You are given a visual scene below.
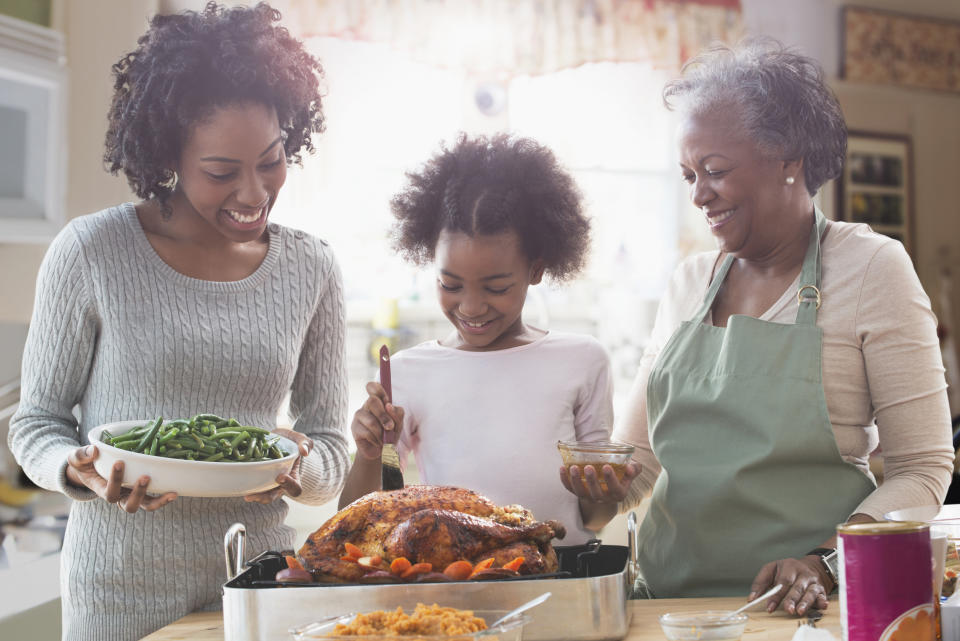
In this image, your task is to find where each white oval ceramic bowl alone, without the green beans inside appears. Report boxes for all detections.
[88,420,297,497]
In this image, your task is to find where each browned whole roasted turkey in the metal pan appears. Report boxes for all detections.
[298,485,566,583]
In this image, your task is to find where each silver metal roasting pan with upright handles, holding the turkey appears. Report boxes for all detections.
[223,513,637,641]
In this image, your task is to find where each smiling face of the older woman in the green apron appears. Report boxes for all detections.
[678,111,787,258]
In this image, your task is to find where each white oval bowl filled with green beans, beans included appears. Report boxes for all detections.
[87,414,297,497]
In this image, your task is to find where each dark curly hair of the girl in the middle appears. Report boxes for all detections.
[390,134,590,282]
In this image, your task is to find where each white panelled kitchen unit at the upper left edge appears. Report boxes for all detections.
[0,16,66,242]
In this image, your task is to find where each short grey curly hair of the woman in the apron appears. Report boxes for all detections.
[663,38,847,196]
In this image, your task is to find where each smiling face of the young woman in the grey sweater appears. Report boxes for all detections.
[175,102,287,243]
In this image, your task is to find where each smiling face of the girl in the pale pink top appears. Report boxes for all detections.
[434,230,543,351]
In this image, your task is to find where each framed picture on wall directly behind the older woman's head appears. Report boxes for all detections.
[837,131,916,262]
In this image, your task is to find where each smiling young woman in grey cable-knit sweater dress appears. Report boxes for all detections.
[10,4,347,641]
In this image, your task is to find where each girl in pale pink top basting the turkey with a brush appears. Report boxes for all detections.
[340,135,636,543]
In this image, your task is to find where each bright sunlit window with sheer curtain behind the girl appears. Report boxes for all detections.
[273,0,739,399]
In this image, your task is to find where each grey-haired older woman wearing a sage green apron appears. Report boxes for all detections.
[564,41,953,614]
